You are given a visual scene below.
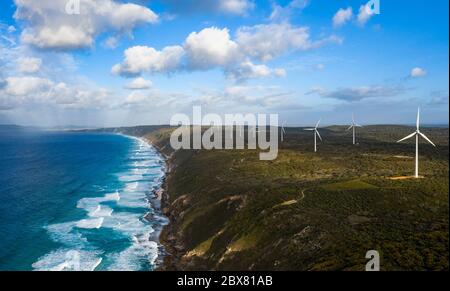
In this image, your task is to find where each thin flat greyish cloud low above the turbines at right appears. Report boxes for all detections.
[306,86,405,102]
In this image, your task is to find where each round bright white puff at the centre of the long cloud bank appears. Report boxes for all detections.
[184,27,239,69]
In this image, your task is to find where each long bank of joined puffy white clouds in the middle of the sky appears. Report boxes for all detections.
[112,23,342,80]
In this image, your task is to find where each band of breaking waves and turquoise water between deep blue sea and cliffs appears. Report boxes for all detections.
[33,137,167,271]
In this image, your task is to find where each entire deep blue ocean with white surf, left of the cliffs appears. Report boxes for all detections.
[0,131,167,271]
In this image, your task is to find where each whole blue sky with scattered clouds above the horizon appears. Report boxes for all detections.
[0,0,449,127]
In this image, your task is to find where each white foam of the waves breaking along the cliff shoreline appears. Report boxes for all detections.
[33,139,164,271]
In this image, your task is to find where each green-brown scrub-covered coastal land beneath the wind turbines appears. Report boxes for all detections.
[110,126,449,271]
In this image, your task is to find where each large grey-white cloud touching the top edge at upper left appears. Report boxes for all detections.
[14,0,158,50]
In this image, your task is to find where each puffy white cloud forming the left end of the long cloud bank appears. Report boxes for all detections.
[112,46,184,75]
